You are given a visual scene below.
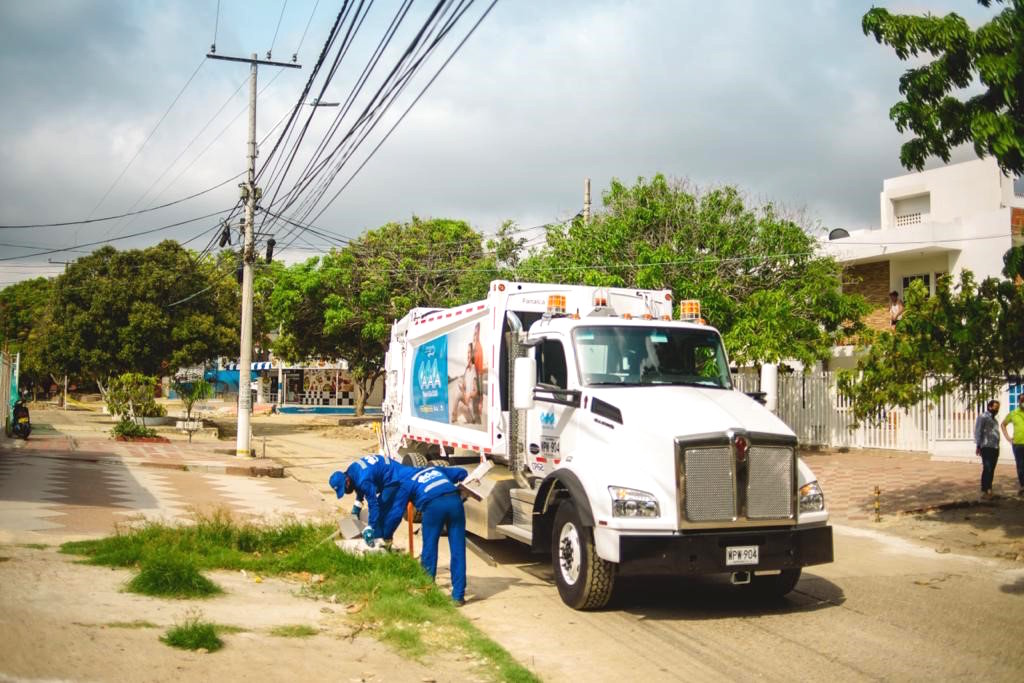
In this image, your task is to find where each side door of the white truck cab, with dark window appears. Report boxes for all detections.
[526,336,580,477]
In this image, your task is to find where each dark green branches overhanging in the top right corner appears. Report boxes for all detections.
[861,0,1024,175]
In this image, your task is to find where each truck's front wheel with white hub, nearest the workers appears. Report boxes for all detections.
[551,501,615,609]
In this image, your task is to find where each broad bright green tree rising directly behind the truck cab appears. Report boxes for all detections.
[516,175,867,364]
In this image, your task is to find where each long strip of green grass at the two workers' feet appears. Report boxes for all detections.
[60,512,538,682]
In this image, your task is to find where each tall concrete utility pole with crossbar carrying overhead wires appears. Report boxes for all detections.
[206,52,302,458]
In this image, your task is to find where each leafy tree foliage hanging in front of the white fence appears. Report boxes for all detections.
[840,247,1024,421]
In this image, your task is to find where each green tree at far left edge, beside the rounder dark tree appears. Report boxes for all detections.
[0,278,53,392]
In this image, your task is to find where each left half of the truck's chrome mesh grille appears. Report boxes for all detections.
[683,445,736,522]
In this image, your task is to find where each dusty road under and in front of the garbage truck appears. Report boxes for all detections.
[464,527,1024,683]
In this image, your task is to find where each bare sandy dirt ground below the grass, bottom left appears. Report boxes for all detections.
[0,546,482,683]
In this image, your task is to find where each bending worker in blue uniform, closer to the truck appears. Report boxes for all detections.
[381,467,468,605]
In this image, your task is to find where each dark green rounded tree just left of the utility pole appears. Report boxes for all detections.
[44,241,239,390]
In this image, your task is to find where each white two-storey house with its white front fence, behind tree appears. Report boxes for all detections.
[777,158,1024,461]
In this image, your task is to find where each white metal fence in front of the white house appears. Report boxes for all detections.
[733,373,1007,451]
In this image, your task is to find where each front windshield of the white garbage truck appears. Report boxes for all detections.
[572,326,732,389]
